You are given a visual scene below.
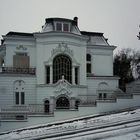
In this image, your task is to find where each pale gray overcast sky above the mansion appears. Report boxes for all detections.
[0,0,140,50]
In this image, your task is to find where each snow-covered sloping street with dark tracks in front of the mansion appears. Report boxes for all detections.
[0,109,140,140]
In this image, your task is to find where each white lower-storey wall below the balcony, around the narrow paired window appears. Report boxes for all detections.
[0,75,36,107]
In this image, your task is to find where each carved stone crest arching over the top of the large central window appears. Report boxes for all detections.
[51,42,73,57]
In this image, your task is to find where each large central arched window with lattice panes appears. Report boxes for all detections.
[53,55,72,83]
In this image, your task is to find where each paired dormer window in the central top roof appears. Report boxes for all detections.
[55,22,70,32]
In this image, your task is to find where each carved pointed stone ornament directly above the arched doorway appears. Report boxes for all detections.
[54,76,72,95]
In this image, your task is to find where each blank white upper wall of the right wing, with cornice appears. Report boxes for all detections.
[87,46,113,76]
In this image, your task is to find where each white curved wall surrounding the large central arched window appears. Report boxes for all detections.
[36,33,86,85]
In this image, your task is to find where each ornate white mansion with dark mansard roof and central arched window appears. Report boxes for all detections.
[0,17,138,125]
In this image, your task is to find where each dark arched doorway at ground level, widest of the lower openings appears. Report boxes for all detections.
[56,97,70,109]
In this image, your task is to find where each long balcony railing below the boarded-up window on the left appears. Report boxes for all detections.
[0,67,36,75]
